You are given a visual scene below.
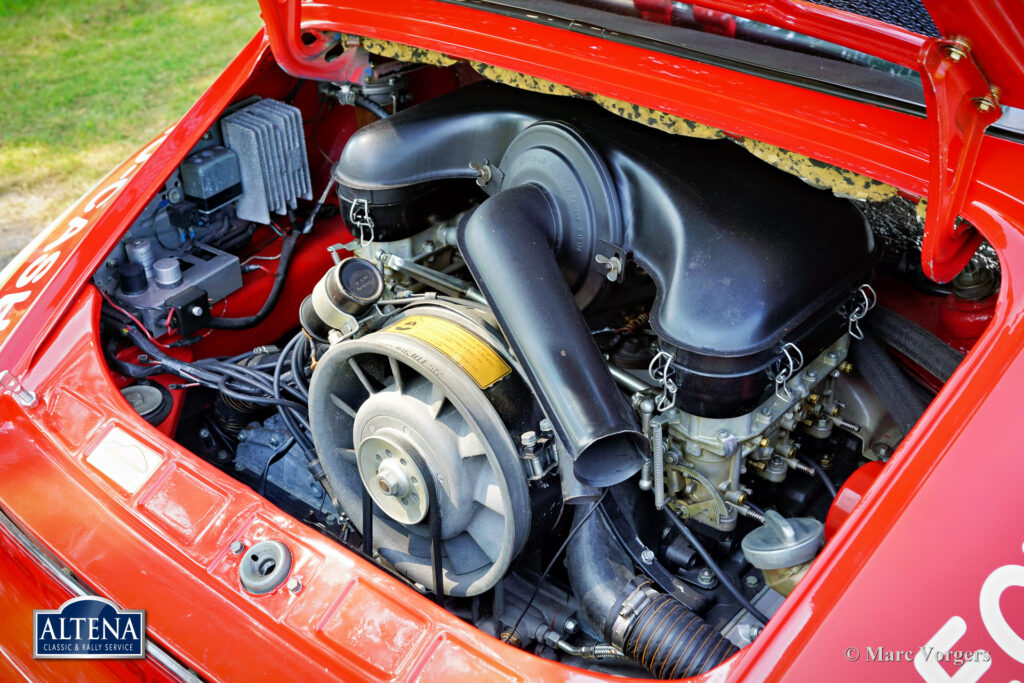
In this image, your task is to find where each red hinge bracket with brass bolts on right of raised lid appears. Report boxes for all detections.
[921,37,1001,283]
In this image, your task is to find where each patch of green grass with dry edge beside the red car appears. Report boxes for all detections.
[0,0,260,240]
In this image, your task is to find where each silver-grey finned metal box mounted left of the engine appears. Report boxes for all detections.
[221,99,312,224]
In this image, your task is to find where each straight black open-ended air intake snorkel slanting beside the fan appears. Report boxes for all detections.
[459,183,642,486]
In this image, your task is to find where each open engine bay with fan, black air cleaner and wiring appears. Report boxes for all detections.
[93,47,999,678]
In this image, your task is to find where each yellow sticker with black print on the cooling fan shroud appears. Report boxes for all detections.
[381,315,512,389]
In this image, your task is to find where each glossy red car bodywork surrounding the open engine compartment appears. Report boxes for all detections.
[0,0,1024,681]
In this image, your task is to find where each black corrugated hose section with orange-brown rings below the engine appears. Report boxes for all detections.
[623,593,737,679]
